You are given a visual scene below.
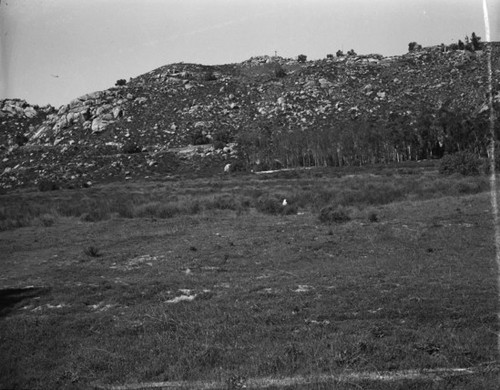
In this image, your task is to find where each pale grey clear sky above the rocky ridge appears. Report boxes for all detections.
[0,0,500,107]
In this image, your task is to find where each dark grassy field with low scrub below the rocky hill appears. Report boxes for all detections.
[0,168,499,389]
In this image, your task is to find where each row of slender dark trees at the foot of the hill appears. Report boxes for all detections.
[236,107,499,170]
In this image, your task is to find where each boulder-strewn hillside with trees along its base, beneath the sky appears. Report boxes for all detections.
[0,43,500,189]
